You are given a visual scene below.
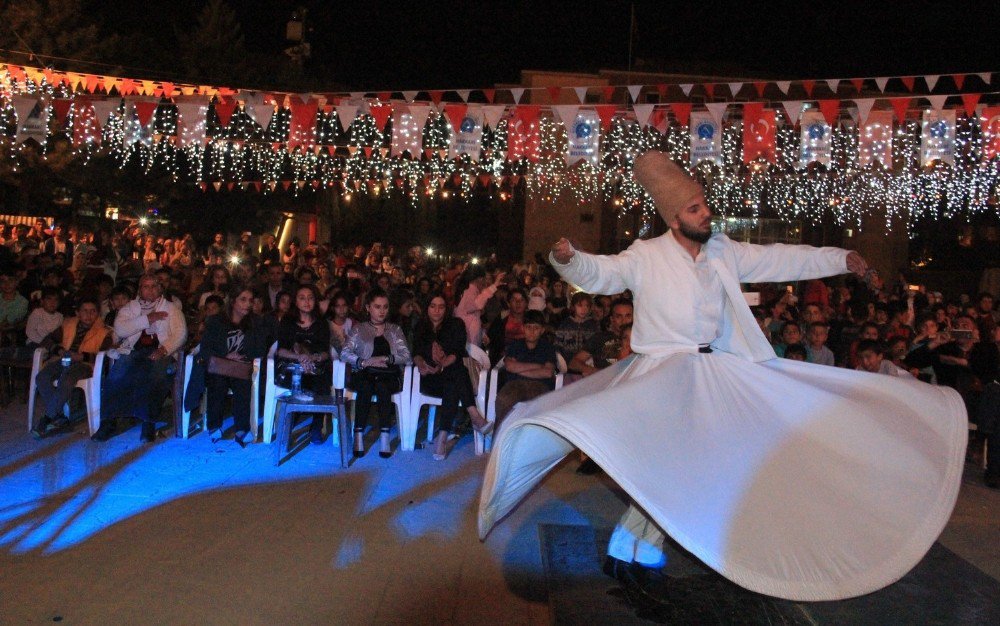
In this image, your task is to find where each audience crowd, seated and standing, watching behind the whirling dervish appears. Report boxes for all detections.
[0,220,1000,480]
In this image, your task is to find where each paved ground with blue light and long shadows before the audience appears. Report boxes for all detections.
[0,402,1000,624]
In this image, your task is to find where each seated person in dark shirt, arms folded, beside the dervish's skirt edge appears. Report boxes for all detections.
[496,311,556,424]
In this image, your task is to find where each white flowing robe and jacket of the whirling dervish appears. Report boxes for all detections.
[479,233,967,600]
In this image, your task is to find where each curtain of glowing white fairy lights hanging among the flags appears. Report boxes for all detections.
[0,64,1000,229]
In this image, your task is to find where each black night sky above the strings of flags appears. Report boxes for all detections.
[100,0,1000,90]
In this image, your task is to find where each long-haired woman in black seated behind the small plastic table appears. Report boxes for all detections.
[277,285,333,444]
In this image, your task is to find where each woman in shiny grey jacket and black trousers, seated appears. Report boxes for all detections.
[340,287,410,459]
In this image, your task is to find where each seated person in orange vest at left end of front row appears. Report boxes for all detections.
[31,296,111,439]
